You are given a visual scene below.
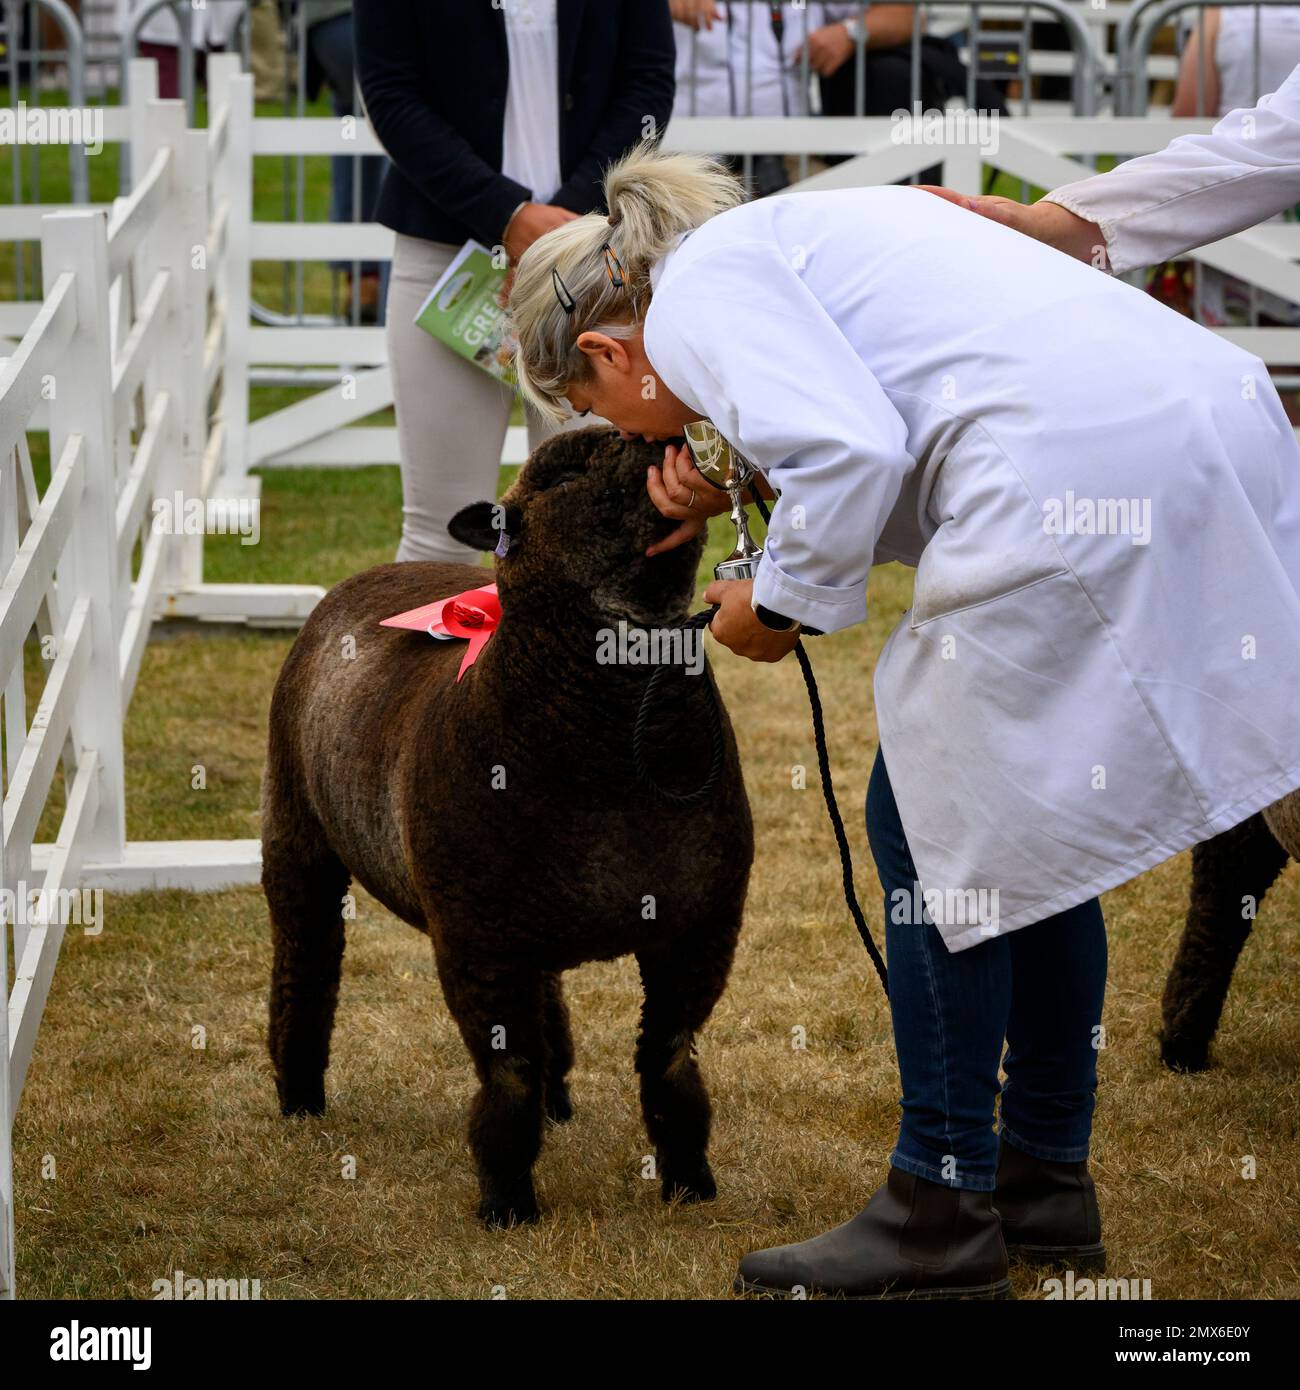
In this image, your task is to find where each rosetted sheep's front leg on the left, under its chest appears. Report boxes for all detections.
[438,956,546,1227]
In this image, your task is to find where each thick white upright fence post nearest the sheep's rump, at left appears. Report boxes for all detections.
[40,210,127,863]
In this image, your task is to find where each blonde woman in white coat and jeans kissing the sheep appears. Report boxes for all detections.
[512,141,1300,1295]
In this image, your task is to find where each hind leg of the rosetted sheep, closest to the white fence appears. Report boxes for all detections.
[261,838,349,1115]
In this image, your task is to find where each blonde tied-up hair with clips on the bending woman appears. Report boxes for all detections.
[509,142,745,420]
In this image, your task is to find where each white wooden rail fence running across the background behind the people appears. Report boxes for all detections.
[224,96,1300,491]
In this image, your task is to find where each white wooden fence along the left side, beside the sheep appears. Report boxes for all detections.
[0,60,321,1297]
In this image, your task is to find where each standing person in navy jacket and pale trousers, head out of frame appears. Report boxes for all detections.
[353,0,674,562]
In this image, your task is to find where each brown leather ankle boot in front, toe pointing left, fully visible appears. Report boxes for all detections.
[733,1168,1011,1298]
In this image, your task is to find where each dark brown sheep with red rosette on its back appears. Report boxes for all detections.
[263,430,754,1225]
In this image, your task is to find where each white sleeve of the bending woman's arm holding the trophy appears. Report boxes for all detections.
[645,242,913,632]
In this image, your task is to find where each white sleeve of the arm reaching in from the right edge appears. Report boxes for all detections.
[1043,67,1300,275]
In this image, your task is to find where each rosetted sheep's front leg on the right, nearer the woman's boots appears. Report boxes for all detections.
[637,924,738,1202]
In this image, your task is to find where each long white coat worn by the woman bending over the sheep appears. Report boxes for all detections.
[645,188,1300,951]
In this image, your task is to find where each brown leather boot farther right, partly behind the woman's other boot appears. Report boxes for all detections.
[993,1140,1105,1272]
